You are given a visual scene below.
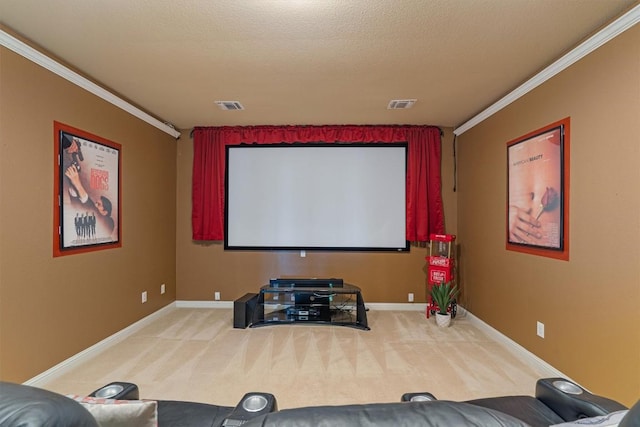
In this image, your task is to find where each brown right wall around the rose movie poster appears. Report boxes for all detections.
[458,26,640,405]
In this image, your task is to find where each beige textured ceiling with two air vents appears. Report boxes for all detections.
[0,0,638,129]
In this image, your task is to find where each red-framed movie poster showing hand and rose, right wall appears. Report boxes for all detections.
[507,118,570,260]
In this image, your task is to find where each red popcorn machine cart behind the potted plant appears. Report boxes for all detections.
[426,234,456,319]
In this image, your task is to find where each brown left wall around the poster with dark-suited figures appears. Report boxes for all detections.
[0,48,176,381]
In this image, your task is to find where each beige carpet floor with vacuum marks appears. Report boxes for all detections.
[43,308,554,409]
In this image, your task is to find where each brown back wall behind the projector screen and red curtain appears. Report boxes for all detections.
[177,129,457,303]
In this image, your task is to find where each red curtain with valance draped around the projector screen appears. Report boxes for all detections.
[191,126,445,242]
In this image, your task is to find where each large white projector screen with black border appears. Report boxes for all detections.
[224,143,409,251]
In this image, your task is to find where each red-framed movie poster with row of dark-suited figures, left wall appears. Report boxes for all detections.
[53,122,122,256]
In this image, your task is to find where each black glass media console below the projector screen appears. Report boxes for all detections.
[250,279,369,330]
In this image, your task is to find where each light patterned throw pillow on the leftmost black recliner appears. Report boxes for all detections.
[67,395,158,427]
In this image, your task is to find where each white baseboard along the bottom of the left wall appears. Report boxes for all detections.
[24,303,176,387]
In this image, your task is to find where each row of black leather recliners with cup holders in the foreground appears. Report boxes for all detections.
[0,378,640,427]
